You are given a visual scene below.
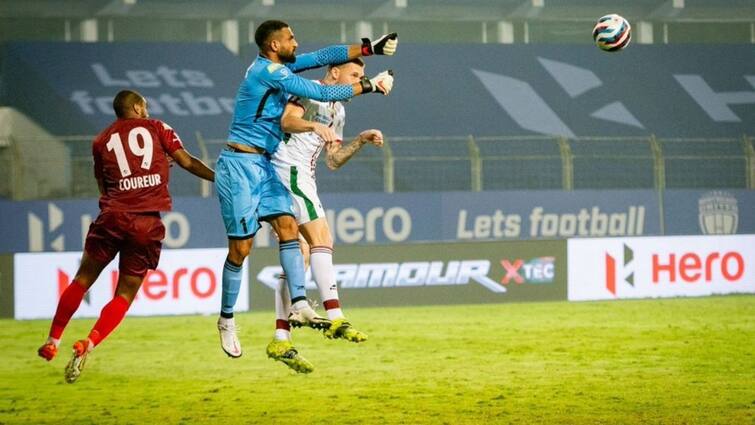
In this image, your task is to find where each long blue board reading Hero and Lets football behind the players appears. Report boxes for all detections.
[0,190,661,252]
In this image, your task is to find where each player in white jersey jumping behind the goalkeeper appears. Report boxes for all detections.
[272,58,383,342]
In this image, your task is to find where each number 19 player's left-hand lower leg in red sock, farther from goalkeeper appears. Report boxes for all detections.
[37,252,107,361]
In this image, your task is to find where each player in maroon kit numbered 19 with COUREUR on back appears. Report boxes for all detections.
[37,90,215,383]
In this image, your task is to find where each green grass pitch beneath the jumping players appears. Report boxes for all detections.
[0,296,755,425]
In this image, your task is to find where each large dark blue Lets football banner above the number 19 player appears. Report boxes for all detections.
[0,42,245,139]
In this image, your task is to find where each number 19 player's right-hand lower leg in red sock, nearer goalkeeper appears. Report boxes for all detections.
[65,273,144,384]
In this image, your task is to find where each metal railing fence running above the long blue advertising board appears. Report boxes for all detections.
[0,133,755,199]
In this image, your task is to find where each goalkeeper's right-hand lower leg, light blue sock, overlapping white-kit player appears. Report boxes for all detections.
[270,215,330,329]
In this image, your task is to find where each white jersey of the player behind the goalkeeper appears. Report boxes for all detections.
[272,81,346,179]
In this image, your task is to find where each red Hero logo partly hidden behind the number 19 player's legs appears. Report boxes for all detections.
[58,267,218,298]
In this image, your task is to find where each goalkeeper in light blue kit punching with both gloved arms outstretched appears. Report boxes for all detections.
[215,20,397,372]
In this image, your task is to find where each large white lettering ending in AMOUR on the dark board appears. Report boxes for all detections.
[257,260,506,294]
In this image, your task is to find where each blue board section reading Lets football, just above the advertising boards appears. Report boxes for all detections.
[442,190,660,240]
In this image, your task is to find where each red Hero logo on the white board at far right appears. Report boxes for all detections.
[605,244,745,296]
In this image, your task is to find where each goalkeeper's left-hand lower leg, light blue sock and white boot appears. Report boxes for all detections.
[217,238,254,358]
